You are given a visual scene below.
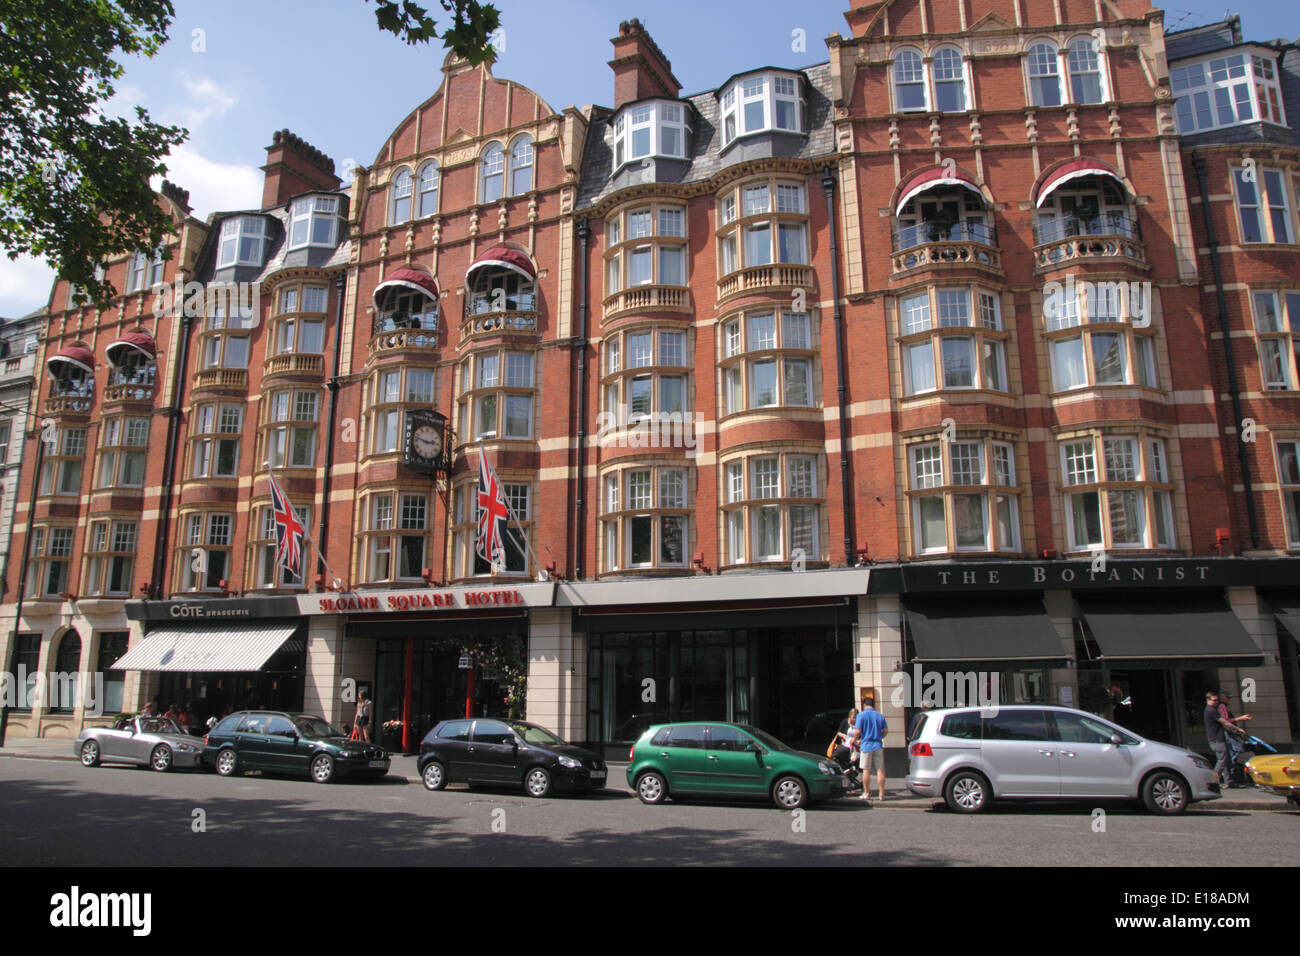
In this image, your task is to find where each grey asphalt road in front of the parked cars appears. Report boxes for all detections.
[0,757,1300,868]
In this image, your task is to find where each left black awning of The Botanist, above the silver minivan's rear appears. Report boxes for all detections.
[905,597,1069,665]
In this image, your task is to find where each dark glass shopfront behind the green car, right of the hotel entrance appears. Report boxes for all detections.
[586,611,853,749]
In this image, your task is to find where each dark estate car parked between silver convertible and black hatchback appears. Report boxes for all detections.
[203,710,390,783]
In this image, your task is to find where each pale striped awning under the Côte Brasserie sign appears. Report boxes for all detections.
[112,624,296,671]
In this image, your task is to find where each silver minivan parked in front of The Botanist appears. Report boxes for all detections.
[907,705,1221,813]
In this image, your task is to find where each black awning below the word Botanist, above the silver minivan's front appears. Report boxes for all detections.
[1078,594,1264,667]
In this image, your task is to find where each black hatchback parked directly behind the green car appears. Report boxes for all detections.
[419,718,607,797]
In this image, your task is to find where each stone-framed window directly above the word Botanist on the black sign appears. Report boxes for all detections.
[1061,434,1175,551]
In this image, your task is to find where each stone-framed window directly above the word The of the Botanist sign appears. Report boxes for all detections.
[907,438,1021,555]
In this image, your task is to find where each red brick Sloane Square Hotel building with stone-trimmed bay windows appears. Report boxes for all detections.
[5,0,1300,752]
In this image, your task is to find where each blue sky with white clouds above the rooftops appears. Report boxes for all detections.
[0,0,1300,316]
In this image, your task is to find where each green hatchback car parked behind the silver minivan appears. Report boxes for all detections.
[628,723,849,810]
